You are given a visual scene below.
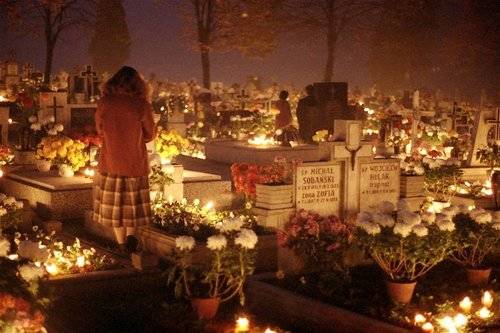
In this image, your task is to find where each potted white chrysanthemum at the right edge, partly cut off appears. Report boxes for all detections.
[451,206,500,285]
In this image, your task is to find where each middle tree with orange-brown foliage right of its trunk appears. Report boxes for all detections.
[182,0,282,88]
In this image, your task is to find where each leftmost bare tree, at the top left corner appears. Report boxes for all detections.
[0,0,94,85]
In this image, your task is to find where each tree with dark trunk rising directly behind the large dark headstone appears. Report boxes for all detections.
[286,0,379,82]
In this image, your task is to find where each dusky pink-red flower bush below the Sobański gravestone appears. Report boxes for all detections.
[278,209,353,273]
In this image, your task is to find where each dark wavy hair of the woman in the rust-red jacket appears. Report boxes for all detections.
[103,66,149,100]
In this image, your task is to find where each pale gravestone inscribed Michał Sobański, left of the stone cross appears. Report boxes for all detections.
[295,162,344,216]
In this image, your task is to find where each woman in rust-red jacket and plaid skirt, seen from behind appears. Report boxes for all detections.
[93,66,155,249]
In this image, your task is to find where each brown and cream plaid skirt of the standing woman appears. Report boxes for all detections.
[93,172,151,227]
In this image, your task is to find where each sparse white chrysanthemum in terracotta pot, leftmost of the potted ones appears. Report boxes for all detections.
[168,228,257,319]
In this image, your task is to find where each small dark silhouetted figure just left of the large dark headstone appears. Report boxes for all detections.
[297,85,318,143]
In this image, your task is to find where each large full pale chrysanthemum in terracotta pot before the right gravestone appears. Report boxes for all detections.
[356,202,455,303]
